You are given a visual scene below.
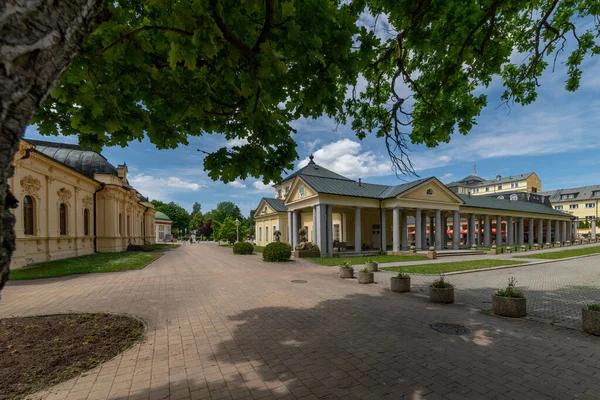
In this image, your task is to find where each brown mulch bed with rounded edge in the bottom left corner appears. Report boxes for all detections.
[0,314,145,400]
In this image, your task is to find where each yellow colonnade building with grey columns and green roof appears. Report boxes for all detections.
[254,156,573,256]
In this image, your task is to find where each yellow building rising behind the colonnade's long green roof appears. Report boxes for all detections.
[446,172,542,196]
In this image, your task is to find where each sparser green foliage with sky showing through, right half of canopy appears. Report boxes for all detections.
[338,0,600,173]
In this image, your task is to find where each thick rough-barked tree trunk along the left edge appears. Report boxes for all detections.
[0,0,105,296]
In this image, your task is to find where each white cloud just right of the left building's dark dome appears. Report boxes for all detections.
[129,173,206,201]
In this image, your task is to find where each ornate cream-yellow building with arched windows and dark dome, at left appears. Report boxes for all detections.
[9,140,155,268]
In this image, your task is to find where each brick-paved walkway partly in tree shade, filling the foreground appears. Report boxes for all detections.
[0,244,600,400]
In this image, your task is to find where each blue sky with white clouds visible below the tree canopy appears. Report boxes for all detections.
[25,42,600,215]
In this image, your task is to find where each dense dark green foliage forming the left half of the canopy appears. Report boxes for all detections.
[35,0,364,184]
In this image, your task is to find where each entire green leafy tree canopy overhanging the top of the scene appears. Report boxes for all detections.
[30,0,600,182]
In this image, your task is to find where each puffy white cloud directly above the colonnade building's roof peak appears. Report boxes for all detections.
[298,138,393,178]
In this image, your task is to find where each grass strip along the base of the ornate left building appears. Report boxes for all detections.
[10,251,164,280]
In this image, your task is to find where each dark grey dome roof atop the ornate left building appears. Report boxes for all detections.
[25,139,117,178]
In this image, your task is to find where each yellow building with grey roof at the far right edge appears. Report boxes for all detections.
[540,185,600,238]
